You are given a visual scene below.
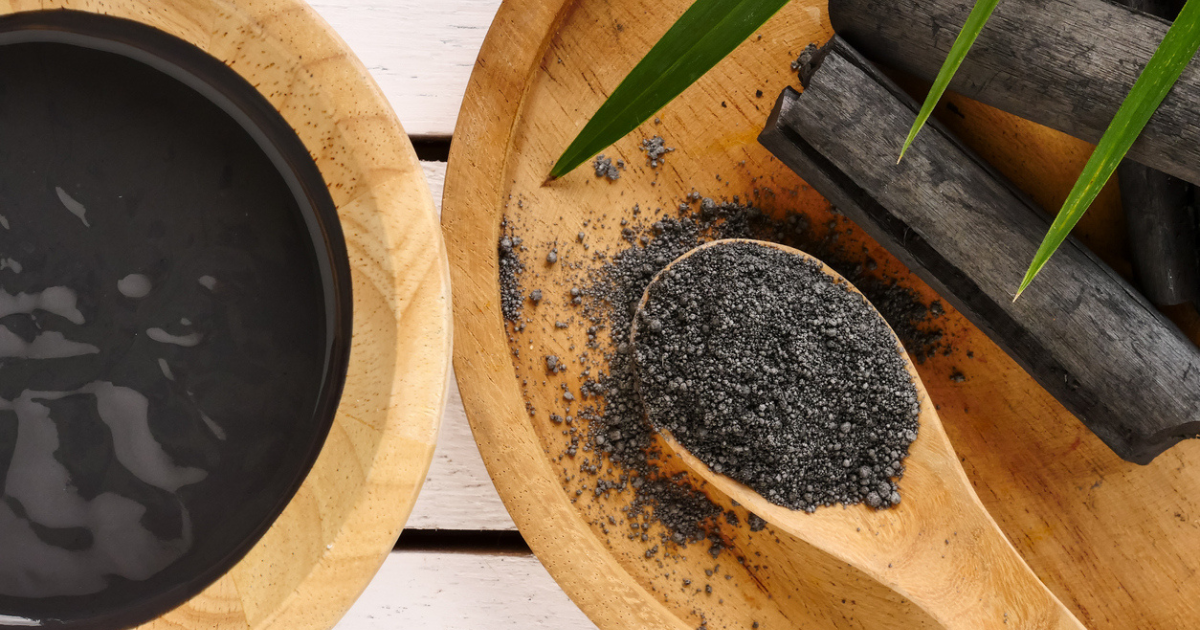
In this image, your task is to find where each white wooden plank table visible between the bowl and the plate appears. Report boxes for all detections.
[302,0,595,630]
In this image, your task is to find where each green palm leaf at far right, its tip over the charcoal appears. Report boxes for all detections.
[1013,0,1200,300]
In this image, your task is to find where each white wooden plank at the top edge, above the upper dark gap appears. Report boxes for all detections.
[310,0,500,137]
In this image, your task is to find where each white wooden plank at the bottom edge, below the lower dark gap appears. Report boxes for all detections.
[337,552,596,630]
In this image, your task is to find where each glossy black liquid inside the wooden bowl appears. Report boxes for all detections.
[0,43,328,604]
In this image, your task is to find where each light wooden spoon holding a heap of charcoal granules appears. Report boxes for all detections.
[631,239,1084,630]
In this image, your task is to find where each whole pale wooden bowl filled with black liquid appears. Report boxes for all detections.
[0,0,450,629]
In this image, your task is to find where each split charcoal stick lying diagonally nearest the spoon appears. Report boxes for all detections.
[760,37,1200,464]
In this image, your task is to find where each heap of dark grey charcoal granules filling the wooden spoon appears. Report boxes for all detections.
[634,241,920,512]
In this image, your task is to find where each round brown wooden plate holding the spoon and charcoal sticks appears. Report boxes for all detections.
[443,0,1200,629]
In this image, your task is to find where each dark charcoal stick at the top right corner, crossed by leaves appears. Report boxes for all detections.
[829,0,1200,184]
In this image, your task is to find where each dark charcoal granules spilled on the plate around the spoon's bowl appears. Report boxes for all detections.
[500,191,944,553]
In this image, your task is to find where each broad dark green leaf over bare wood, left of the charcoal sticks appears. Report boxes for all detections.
[550,0,787,179]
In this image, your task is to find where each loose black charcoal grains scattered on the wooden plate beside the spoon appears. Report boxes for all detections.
[498,198,949,559]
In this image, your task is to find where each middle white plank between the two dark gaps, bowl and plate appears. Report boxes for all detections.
[404,162,517,530]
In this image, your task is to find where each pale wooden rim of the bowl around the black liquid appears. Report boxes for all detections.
[0,0,450,630]
